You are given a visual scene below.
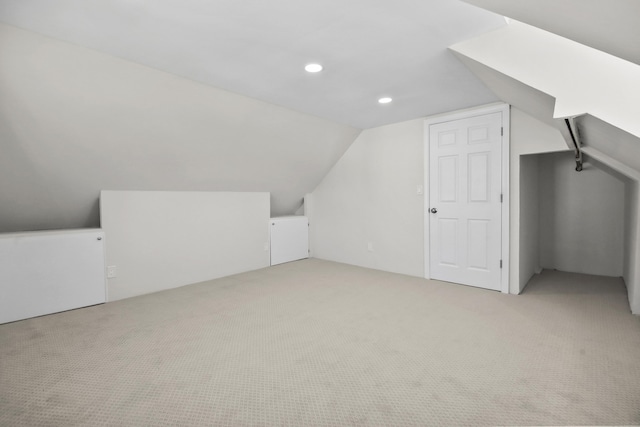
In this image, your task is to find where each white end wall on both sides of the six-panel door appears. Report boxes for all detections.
[305,108,567,293]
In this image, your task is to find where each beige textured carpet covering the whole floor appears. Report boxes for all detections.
[0,259,640,426]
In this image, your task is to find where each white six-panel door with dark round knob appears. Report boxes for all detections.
[426,112,502,290]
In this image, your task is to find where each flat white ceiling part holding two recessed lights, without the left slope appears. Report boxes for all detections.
[0,0,505,128]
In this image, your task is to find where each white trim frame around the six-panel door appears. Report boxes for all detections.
[423,102,510,294]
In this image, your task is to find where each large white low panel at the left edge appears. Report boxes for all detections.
[0,229,106,323]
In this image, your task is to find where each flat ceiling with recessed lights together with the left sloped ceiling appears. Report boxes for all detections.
[0,0,505,232]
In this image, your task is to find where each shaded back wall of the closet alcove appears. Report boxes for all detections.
[539,153,625,276]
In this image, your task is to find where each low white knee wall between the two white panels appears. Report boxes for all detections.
[100,191,269,301]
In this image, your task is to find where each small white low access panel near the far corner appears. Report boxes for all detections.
[269,216,309,265]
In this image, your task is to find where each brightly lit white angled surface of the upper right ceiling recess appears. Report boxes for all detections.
[451,21,640,136]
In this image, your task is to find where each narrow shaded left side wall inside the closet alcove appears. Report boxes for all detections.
[518,155,540,287]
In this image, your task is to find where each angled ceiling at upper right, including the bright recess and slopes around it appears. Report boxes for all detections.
[451,0,640,170]
